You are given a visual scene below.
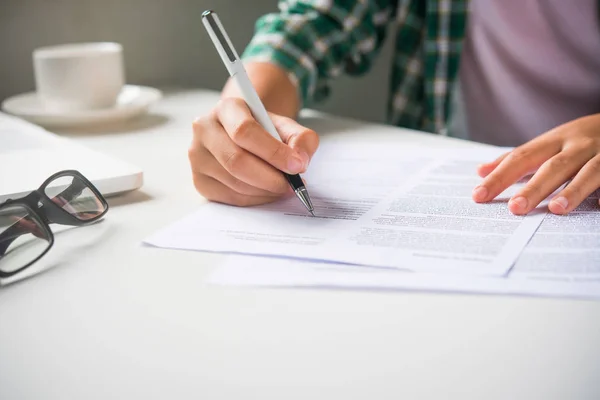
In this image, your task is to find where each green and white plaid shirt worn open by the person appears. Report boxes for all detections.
[243,0,468,133]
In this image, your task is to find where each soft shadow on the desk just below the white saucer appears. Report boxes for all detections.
[53,113,170,137]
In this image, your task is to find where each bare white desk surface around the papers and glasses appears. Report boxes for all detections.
[0,90,600,400]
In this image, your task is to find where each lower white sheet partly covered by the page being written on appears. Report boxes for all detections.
[210,191,600,299]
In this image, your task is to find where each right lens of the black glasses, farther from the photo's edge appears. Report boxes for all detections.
[44,175,106,221]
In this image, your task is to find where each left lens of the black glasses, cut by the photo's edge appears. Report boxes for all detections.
[0,206,50,274]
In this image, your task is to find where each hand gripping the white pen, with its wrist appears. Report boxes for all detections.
[189,10,319,212]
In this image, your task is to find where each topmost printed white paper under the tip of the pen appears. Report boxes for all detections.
[146,144,545,275]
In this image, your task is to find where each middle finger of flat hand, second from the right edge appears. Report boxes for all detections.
[508,149,592,215]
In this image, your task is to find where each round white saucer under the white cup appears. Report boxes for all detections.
[2,85,162,128]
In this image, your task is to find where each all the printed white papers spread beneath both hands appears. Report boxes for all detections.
[146,144,600,297]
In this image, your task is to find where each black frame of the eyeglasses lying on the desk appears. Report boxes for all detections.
[0,170,108,278]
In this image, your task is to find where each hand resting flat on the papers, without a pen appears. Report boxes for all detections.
[473,114,600,215]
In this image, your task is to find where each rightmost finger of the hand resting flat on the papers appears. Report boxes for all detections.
[548,155,600,215]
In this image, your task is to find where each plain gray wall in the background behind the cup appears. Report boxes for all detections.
[0,0,392,121]
